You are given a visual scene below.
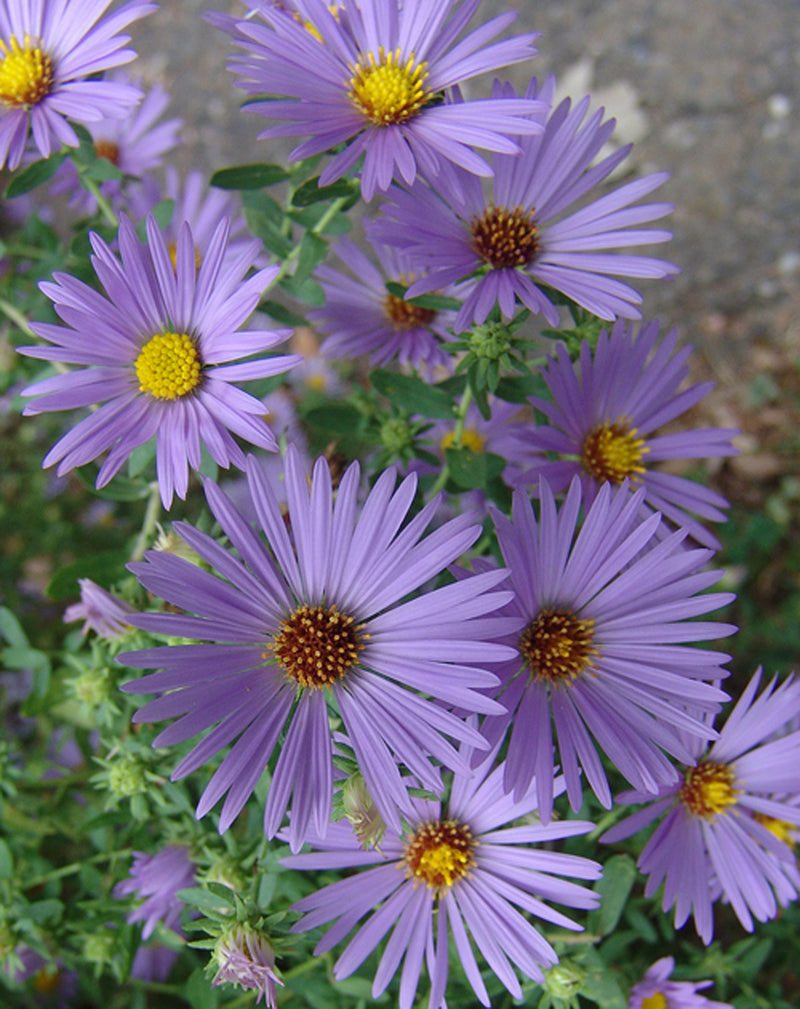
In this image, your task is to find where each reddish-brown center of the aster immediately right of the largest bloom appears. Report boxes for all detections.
[520,609,597,685]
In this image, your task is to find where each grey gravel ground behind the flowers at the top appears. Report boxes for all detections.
[129,0,800,382]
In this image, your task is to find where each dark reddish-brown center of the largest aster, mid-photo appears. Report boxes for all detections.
[263,605,369,688]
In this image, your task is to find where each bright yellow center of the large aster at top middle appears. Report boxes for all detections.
[348,45,432,126]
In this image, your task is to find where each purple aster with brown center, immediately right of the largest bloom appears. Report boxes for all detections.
[482,479,735,822]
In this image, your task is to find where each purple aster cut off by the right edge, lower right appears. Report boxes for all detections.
[601,669,800,944]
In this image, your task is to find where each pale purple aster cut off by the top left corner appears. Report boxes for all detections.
[0,0,155,171]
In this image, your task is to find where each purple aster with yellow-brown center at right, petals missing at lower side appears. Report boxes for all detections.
[508,322,738,548]
